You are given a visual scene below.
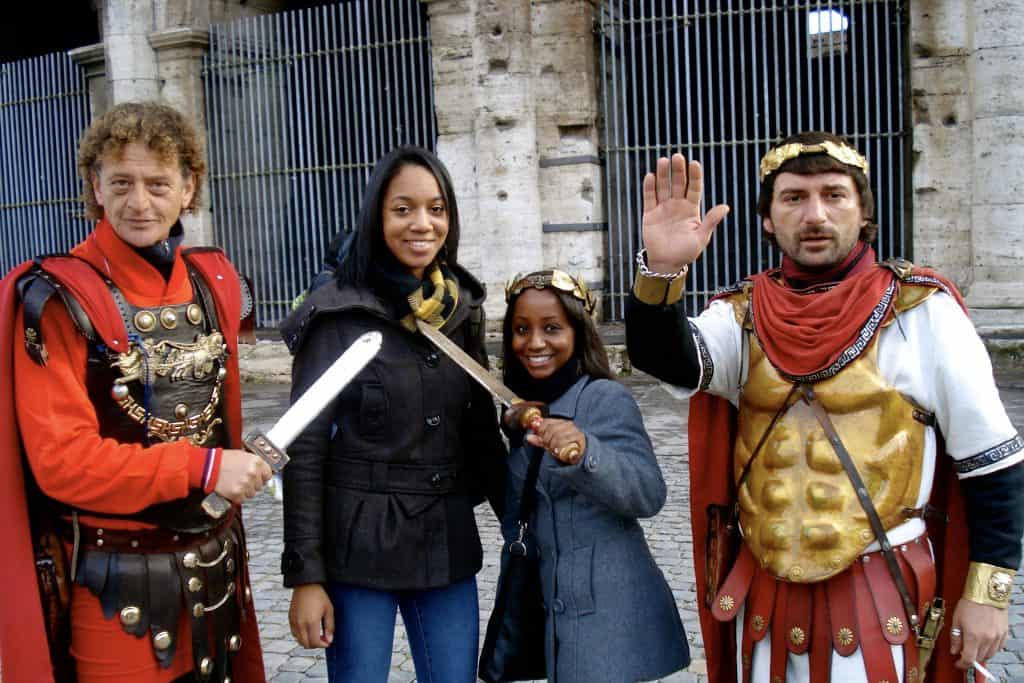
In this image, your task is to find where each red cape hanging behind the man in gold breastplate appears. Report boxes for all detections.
[688,268,969,683]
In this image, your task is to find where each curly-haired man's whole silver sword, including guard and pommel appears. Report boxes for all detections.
[203,332,382,519]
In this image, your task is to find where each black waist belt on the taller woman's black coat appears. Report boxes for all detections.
[328,458,461,495]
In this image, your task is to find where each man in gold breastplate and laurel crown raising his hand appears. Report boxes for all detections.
[627,132,1024,683]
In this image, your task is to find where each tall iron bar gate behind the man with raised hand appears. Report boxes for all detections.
[599,0,911,317]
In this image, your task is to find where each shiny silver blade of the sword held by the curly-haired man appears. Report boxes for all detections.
[266,332,383,451]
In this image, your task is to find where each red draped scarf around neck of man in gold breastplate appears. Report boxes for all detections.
[751,243,893,376]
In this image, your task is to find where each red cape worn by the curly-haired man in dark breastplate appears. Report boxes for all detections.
[0,240,266,683]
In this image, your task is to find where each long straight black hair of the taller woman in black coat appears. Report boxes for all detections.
[337,145,459,287]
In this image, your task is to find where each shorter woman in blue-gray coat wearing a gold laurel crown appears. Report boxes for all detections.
[502,270,690,683]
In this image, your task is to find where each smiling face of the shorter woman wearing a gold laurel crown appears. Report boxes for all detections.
[512,289,575,380]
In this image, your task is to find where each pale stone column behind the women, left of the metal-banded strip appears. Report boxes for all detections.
[425,0,542,318]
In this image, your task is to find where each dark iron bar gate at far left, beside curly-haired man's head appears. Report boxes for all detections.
[0,52,92,272]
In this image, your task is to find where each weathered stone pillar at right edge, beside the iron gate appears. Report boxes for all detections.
[910,0,1024,332]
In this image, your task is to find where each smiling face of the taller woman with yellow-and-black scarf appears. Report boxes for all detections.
[381,164,449,279]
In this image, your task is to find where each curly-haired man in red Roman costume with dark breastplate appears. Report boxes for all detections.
[0,103,270,683]
